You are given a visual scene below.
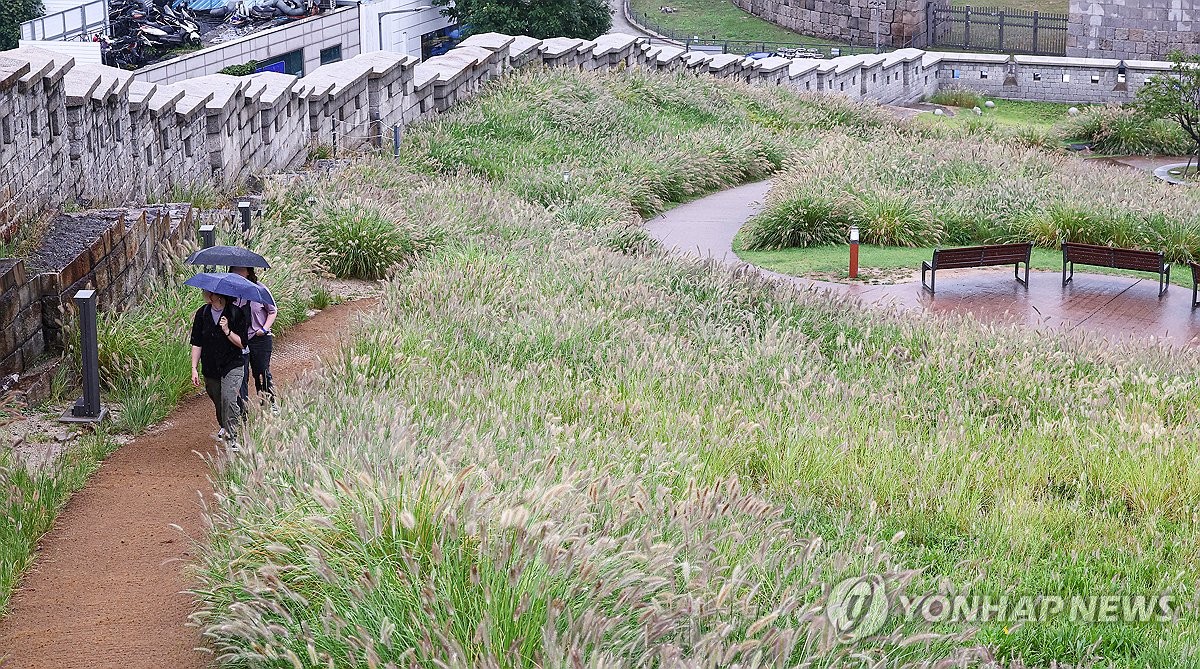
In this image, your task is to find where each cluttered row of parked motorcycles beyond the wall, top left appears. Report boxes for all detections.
[97,0,320,70]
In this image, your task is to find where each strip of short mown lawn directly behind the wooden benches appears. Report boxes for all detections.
[734,245,1192,288]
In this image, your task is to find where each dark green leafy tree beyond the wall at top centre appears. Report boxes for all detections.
[433,0,612,40]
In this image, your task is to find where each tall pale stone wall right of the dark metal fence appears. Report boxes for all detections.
[1067,0,1200,59]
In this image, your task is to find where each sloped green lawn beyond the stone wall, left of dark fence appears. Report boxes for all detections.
[629,0,830,47]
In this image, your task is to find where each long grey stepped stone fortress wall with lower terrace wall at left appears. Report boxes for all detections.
[0,34,1169,383]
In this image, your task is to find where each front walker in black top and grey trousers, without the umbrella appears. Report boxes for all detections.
[192,290,250,451]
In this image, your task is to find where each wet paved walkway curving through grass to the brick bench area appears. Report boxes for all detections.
[646,181,1200,345]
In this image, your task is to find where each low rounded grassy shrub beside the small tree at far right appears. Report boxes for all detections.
[1063,104,1192,156]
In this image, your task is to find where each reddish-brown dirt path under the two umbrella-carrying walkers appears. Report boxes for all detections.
[0,300,373,669]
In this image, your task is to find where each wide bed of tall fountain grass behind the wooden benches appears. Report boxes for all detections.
[740,131,1200,261]
